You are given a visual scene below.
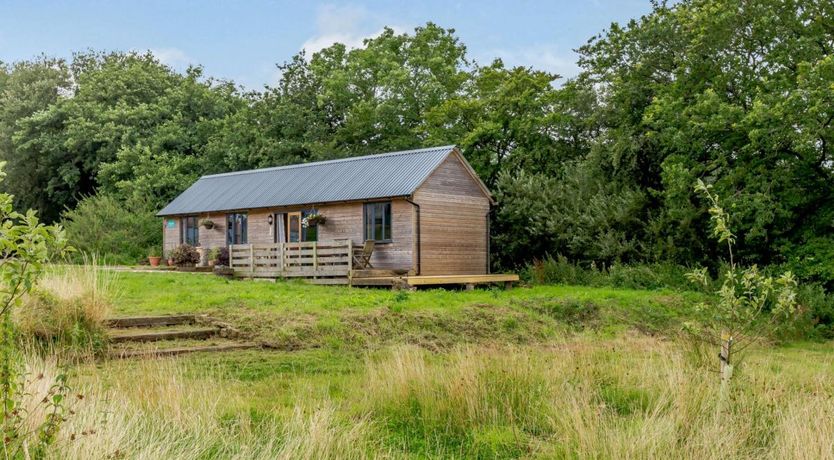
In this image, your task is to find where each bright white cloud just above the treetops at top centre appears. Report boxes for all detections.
[301,5,405,57]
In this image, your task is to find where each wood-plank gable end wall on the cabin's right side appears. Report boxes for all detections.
[414,154,490,275]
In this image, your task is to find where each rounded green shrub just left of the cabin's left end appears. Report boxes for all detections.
[62,194,162,264]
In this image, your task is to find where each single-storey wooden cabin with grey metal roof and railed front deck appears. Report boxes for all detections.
[158,146,512,284]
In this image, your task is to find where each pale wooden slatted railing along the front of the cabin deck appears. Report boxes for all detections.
[229,240,353,278]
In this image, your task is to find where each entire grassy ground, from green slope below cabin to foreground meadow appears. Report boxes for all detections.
[46,273,834,459]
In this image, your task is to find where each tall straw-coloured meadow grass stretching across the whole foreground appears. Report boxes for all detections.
[57,334,834,459]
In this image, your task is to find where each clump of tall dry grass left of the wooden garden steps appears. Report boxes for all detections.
[15,257,118,351]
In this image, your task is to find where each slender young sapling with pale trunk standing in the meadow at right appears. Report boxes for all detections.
[686,179,798,383]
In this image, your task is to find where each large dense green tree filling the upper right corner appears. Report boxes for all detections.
[580,0,834,272]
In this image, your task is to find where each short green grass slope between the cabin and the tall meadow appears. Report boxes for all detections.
[116,273,703,351]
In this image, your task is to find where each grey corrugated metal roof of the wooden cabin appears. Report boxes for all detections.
[157,145,454,216]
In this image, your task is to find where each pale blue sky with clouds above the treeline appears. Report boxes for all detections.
[0,0,651,89]
